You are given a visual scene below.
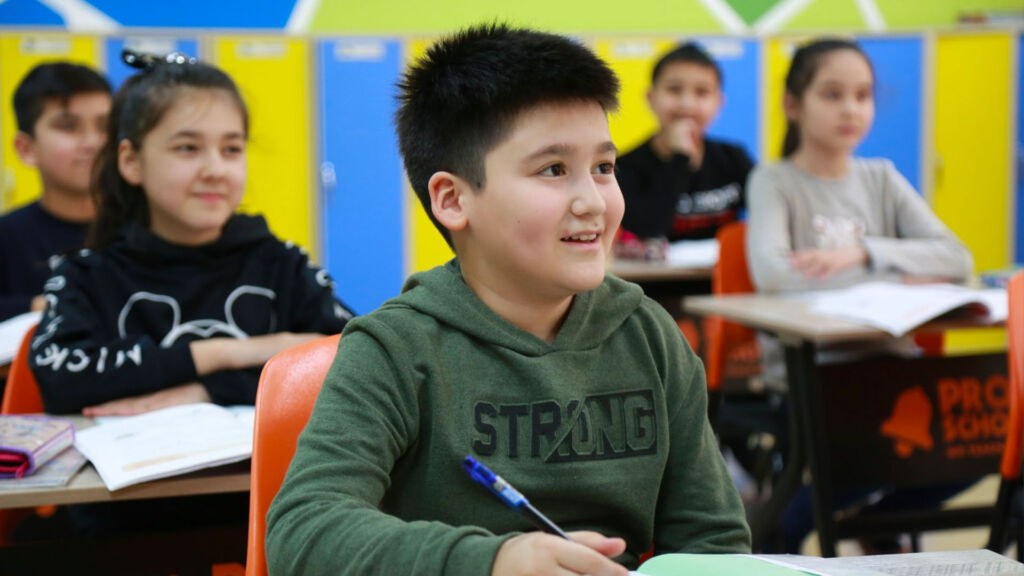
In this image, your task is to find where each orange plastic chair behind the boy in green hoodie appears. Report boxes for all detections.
[246,335,341,576]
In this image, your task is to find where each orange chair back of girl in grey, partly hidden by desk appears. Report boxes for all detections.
[705,222,760,392]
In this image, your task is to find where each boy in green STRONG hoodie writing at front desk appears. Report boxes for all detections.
[266,26,750,576]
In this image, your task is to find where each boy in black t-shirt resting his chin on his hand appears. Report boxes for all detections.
[617,43,753,241]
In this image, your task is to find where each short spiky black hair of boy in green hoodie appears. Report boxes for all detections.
[395,24,618,246]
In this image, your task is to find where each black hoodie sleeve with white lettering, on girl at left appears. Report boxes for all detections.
[29,256,197,414]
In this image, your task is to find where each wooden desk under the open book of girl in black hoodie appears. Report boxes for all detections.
[0,416,249,509]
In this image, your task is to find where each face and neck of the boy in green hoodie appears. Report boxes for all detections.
[453,101,624,303]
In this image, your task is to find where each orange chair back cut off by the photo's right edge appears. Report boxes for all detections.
[999,271,1024,480]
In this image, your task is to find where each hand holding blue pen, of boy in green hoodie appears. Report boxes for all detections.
[490,532,628,576]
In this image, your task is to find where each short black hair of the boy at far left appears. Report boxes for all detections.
[12,61,111,136]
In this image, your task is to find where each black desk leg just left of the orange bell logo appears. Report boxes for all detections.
[785,342,836,558]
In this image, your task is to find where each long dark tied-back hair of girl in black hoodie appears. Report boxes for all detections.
[85,50,249,250]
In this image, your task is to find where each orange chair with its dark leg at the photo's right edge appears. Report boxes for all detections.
[987,272,1024,560]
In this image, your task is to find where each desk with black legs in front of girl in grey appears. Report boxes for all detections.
[683,294,1005,557]
